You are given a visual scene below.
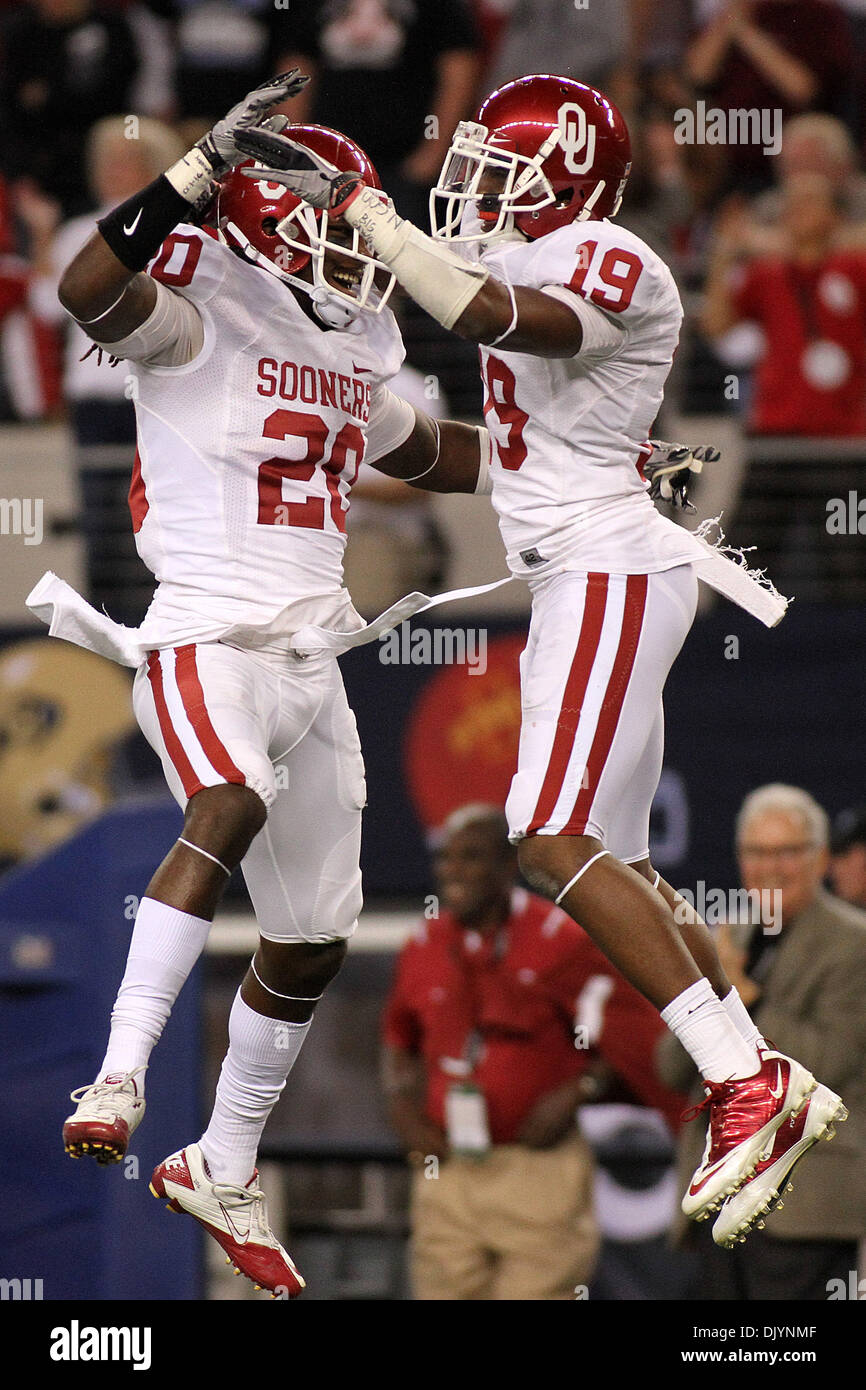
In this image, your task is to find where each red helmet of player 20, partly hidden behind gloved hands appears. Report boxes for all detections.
[210,125,395,328]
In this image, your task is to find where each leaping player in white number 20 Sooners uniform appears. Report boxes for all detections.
[45,72,489,1297]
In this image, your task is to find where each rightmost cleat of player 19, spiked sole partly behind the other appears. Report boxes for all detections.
[713,1086,848,1248]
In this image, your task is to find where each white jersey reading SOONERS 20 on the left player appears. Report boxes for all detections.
[123,225,414,648]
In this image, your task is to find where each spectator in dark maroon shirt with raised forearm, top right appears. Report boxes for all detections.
[685,0,853,189]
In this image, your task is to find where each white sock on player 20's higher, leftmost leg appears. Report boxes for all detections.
[97,898,211,1091]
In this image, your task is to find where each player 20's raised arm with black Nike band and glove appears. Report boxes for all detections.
[58,70,307,343]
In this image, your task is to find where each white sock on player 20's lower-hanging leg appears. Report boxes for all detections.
[199,991,313,1187]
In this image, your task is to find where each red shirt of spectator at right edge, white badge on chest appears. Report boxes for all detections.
[734,252,866,436]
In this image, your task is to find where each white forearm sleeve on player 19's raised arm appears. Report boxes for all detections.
[345,188,489,328]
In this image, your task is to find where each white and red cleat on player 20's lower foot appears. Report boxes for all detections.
[150,1144,304,1298]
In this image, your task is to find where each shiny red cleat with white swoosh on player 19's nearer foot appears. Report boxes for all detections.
[683,1051,817,1220]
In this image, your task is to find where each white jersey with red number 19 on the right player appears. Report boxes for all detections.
[481,221,708,578]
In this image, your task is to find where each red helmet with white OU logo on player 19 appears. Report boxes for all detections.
[430,75,631,242]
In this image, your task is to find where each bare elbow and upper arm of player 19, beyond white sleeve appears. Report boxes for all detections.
[455,277,584,357]
